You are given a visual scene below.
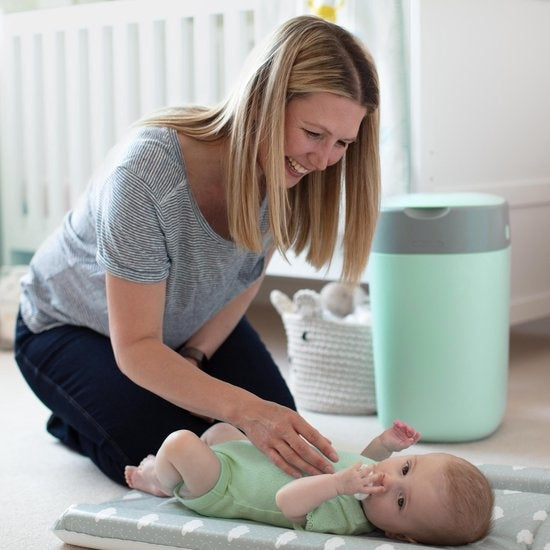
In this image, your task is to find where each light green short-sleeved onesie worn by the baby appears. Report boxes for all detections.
[174,440,373,535]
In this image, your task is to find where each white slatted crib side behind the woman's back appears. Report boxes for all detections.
[0,0,288,264]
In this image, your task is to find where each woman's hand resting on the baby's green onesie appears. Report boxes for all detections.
[238,399,338,477]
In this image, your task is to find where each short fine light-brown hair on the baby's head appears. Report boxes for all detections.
[413,453,494,546]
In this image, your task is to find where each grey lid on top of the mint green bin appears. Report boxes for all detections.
[372,193,510,254]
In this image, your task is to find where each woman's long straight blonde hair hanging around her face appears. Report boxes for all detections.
[142,16,380,283]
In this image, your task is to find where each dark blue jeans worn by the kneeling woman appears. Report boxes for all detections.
[15,317,295,484]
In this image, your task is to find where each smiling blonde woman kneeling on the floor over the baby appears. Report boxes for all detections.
[16,16,379,483]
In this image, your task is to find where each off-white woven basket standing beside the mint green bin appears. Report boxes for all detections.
[271,291,376,414]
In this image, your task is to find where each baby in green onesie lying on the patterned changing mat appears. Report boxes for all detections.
[125,421,493,545]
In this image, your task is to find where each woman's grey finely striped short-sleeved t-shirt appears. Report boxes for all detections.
[21,127,271,348]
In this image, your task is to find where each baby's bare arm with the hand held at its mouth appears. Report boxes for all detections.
[275,462,384,525]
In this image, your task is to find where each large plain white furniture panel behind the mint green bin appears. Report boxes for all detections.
[411,0,550,323]
